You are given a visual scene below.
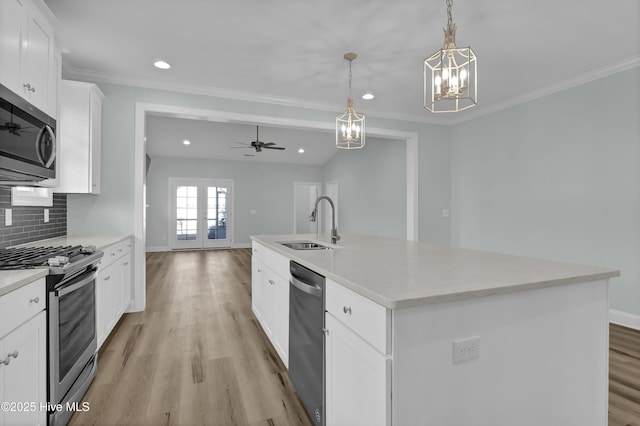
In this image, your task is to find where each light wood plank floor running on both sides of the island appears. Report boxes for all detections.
[69,249,640,426]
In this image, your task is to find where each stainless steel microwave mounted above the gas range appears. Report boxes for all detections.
[0,84,56,183]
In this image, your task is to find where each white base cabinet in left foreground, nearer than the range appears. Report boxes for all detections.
[0,278,47,426]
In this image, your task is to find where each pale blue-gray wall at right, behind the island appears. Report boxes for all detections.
[452,68,640,314]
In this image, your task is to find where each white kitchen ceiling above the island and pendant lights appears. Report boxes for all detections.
[45,0,640,163]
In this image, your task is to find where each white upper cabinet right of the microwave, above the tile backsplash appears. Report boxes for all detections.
[55,80,104,194]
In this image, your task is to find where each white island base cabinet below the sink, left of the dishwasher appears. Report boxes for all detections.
[251,243,289,367]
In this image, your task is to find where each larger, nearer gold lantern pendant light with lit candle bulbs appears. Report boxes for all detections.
[424,0,478,112]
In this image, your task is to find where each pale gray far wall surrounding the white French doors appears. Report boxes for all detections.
[147,157,322,249]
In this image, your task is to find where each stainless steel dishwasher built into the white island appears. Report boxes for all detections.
[289,261,325,425]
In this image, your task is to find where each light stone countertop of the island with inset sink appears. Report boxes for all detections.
[251,234,620,309]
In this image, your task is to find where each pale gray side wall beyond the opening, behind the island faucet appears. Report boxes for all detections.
[323,138,407,239]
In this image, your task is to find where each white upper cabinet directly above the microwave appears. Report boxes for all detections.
[0,0,60,118]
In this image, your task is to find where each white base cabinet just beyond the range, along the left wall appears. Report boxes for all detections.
[96,239,131,349]
